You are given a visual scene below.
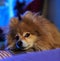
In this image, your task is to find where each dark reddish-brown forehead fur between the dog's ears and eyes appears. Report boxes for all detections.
[19,19,39,34]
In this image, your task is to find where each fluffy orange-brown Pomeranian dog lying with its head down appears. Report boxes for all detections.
[6,11,60,52]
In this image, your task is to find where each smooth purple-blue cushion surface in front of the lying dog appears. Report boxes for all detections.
[0,49,60,61]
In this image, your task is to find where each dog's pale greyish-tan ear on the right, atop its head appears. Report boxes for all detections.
[21,11,40,22]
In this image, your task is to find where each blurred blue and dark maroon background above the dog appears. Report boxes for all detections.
[0,0,60,30]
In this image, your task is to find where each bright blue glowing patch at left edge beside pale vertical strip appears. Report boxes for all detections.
[0,2,9,26]
